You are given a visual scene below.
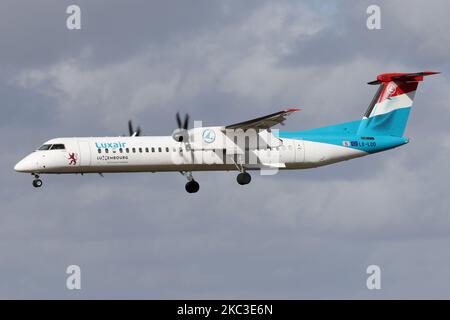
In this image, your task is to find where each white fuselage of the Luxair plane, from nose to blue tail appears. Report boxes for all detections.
[15,130,367,174]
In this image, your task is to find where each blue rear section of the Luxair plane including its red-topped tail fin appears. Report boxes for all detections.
[278,71,438,153]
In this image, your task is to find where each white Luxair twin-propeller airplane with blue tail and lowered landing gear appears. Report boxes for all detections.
[14,71,439,193]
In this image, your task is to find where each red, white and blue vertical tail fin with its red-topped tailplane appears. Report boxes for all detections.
[358,71,439,137]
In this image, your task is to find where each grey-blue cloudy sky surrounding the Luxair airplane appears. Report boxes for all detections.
[0,0,450,299]
